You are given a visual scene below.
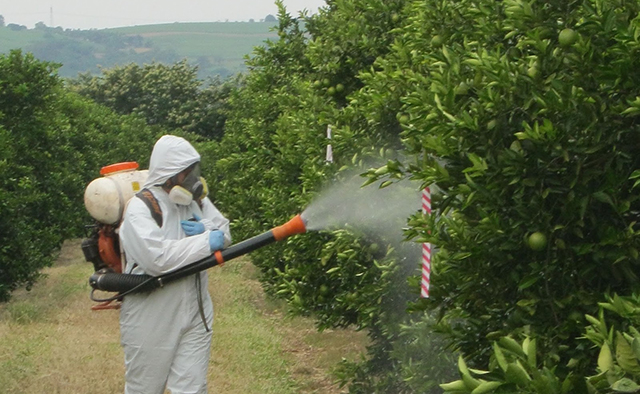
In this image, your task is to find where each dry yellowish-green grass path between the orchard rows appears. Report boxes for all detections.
[0,240,367,394]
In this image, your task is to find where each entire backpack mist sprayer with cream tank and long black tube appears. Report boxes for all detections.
[82,162,306,310]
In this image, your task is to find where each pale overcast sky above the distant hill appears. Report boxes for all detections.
[0,0,326,30]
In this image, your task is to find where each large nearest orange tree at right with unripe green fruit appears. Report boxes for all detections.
[360,0,640,392]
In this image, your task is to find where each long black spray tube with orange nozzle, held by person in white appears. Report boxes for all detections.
[89,215,307,302]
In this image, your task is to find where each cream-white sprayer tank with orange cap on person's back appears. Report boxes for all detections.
[84,161,148,224]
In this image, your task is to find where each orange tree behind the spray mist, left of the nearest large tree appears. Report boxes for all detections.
[209,0,456,393]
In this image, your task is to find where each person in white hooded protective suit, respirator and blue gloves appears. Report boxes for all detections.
[120,135,231,394]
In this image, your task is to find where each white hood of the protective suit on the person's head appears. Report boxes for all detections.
[144,135,200,187]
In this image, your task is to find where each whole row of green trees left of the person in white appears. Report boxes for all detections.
[0,51,158,301]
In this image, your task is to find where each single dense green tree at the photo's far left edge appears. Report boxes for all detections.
[0,51,74,301]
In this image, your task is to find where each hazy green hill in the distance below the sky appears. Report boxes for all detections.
[0,22,277,78]
